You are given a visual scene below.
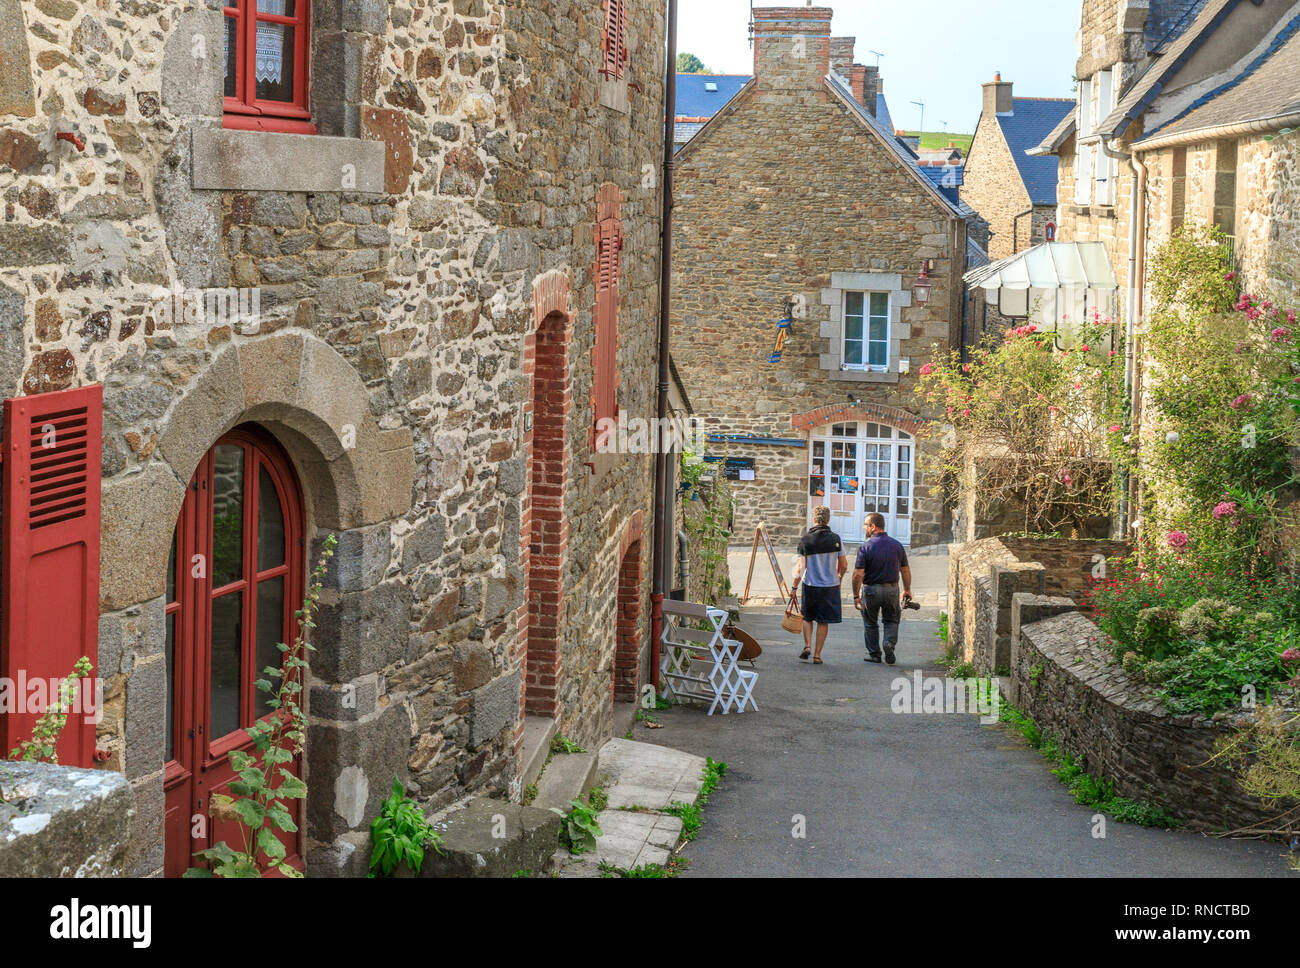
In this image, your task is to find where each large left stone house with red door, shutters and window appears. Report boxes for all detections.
[0,0,666,874]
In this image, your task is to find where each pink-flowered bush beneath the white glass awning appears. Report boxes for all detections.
[919,322,1123,534]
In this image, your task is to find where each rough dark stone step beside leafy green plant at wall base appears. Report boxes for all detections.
[419,796,563,877]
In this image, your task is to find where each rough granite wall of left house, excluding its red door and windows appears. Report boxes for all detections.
[0,0,664,874]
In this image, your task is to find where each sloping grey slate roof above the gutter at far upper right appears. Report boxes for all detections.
[1139,7,1300,144]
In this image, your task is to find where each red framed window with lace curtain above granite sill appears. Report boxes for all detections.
[222,0,316,134]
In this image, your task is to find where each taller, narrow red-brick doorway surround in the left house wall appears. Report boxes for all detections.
[521,292,572,717]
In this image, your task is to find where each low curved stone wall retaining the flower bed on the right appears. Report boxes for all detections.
[1009,594,1286,832]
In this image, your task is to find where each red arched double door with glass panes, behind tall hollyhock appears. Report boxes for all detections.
[164,424,304,877]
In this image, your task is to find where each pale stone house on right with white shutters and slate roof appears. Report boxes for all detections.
[971,0,1300,530]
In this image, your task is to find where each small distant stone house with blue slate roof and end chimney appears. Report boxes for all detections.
[962,74,1073,260]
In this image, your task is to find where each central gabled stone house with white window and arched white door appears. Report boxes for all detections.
[672,6,969,544]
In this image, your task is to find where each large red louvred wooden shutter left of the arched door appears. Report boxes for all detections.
[0,385,104,767]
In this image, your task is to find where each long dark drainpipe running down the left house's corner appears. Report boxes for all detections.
[650,0,677,693]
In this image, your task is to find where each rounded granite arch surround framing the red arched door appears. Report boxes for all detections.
[100,331,415,874]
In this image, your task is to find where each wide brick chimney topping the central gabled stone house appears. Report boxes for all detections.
[754,6,832,95]
